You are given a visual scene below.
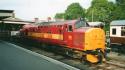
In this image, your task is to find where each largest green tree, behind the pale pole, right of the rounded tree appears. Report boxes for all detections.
[86,0,115,22]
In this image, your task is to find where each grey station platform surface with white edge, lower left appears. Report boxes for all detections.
[0,41,79,70]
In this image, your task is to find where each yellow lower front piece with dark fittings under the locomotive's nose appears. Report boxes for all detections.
[86,51,104,63]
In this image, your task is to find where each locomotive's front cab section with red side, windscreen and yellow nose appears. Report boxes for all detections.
[64,20,105,63]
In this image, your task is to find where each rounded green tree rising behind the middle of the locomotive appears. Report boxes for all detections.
[64,3,85,20]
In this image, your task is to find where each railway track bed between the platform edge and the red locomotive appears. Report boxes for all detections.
[3,38,125,70]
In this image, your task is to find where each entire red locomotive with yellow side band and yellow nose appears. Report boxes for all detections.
[21,20,106,63]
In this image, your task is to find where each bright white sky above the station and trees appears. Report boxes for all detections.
[0,0,114,20]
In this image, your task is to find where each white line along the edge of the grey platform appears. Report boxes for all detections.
[3,41,80,70]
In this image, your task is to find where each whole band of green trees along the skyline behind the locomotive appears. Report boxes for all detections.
[55,0,125,23]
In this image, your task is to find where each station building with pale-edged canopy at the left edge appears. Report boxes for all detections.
[0,10,34,37]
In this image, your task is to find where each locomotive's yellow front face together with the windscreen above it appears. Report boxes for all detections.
[75,20,105,63]
